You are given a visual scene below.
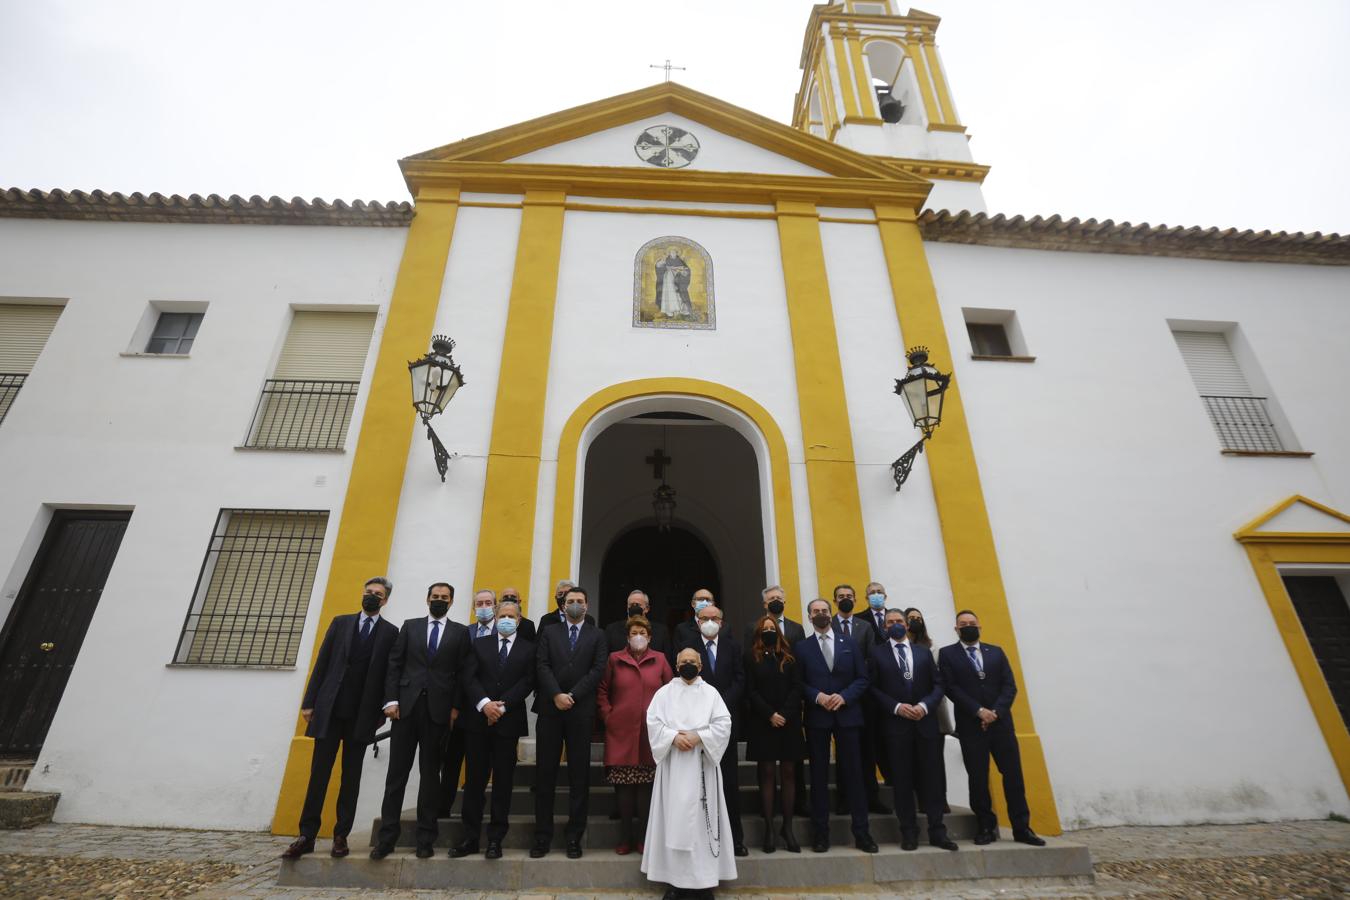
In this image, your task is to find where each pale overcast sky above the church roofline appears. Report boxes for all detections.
[0,0,1350,232]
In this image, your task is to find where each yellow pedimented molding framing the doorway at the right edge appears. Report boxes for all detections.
[1233,494,1350,792]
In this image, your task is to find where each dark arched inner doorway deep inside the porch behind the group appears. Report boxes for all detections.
[597,525,722,630]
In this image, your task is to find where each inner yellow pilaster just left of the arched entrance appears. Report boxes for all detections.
[474,190,566,626]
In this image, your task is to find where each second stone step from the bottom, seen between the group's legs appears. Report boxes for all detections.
[369,808,976,850]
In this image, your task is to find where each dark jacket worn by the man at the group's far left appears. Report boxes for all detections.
[300,613,398,743]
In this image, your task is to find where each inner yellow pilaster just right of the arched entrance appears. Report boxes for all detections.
[778,200,868,596]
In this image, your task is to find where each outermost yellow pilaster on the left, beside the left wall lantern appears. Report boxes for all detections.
[271,186,459,835]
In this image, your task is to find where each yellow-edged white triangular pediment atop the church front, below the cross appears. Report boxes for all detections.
[405,81,930,189]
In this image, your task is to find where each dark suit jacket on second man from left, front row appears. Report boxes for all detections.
[385,615,474,725]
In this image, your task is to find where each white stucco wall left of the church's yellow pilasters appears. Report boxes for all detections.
[0,214,405,828]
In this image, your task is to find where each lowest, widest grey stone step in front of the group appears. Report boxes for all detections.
[277,838,1092,896]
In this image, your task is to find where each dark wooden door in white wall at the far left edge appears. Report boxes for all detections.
[0,510,131,758]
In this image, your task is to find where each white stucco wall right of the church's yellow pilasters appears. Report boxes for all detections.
[923,243,1350,827]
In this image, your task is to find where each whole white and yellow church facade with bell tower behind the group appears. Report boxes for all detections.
[0,0,1350,834]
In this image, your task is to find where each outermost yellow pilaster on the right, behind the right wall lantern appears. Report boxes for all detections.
[876,204,1061,834]
